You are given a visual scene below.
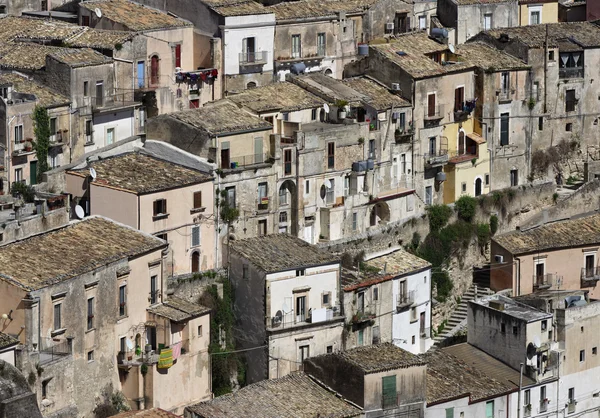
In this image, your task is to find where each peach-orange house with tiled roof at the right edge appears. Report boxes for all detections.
[490,214,600,299]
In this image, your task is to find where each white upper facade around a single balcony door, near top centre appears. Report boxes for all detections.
[222,14,275,75]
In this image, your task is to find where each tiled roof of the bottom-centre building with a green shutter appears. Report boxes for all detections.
[325,343,425,374]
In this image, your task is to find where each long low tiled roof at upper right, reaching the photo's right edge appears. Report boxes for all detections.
[478,22,600,48]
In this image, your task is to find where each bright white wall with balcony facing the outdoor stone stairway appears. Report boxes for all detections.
[392,269,433,354]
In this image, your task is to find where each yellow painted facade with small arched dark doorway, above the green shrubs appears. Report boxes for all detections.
[444,117,490,204]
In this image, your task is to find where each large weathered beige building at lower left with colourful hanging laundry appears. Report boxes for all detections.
[0,217,210,416]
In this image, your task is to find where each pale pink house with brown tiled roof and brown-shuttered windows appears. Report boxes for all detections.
[65,151,217,275]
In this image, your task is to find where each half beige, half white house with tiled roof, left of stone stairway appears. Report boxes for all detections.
[342,250,433,354]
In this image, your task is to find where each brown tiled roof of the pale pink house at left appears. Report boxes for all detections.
[68,152,212,194]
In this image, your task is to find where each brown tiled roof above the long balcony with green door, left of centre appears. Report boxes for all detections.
[164,99,273,135]
